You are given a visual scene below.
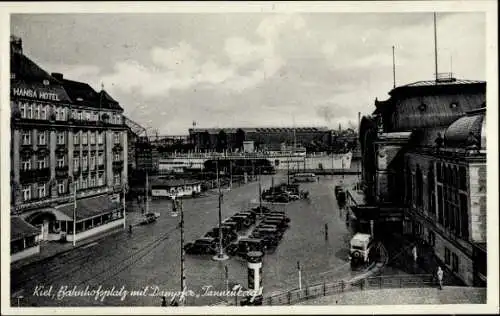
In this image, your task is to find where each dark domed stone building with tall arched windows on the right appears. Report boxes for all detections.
[355,78,486,285]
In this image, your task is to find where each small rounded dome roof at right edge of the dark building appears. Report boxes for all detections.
[444,109,486,149]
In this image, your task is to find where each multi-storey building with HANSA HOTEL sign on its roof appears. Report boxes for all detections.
[10,37,127,260]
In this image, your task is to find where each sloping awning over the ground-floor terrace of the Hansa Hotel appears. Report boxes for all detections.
[56,195,121,222]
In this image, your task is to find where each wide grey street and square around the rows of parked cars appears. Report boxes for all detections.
[11,175,368,306]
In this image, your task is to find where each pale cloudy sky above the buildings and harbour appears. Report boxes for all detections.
[11,12,486,135]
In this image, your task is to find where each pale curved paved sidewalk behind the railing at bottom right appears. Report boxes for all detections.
[297,287,486,305]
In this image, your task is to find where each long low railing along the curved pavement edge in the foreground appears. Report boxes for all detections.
[263,274,435,305]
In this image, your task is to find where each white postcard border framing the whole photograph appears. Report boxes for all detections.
[0,0,499,315]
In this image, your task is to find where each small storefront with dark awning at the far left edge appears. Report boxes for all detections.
[10,216,40,263]
